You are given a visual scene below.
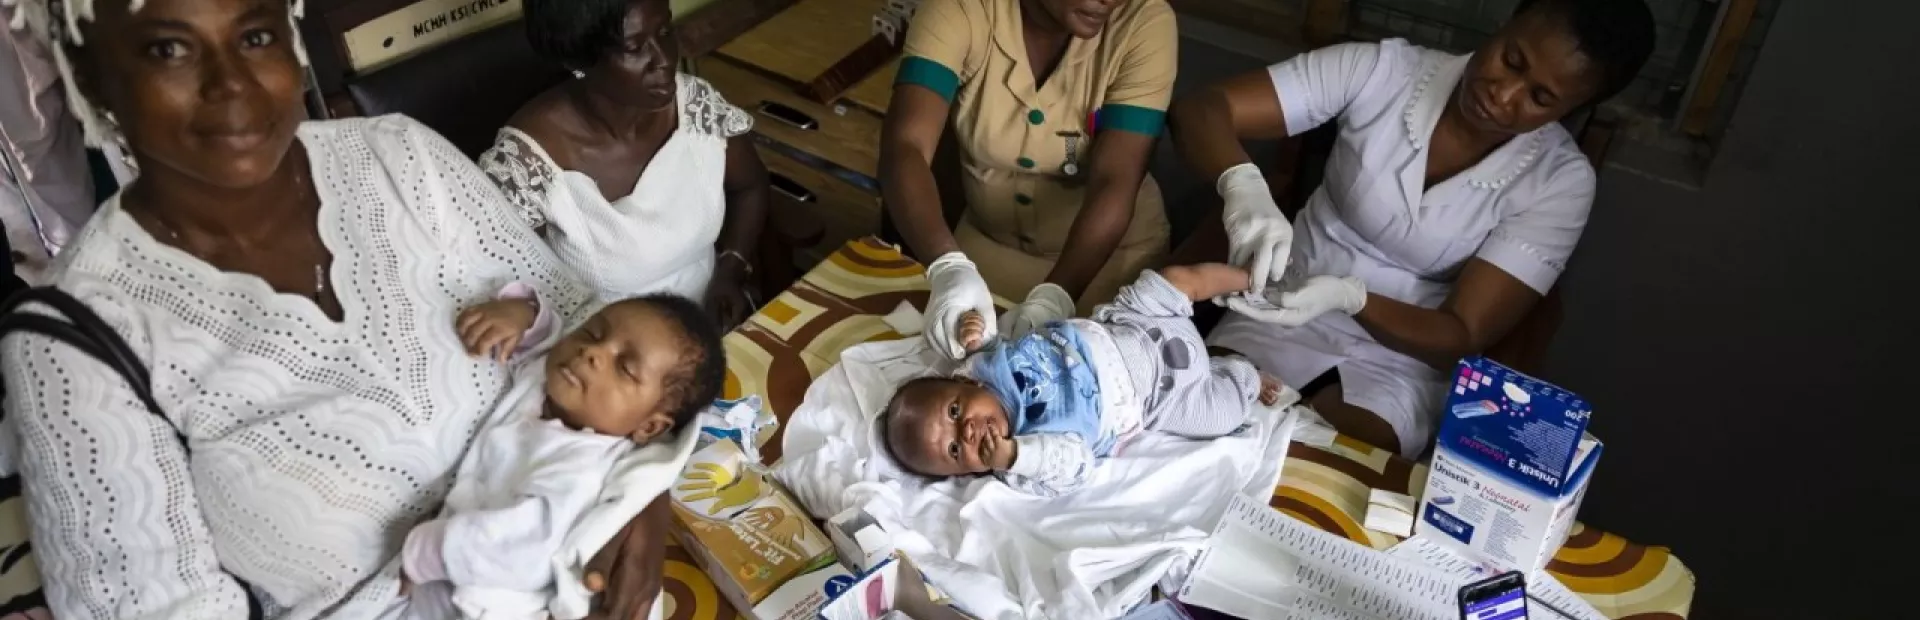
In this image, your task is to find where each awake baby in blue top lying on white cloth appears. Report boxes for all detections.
[881,263,1281,497]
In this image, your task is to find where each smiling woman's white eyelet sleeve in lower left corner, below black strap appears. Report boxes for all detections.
[0,282,248,618]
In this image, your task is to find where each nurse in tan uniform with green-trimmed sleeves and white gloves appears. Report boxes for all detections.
[879,0,1179,357]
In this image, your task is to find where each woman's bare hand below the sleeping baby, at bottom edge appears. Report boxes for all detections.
[582,493,672,620]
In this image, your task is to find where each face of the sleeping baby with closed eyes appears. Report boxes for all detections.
[547,301,687,443]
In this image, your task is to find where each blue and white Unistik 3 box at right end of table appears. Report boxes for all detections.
[1413,357,1605,572]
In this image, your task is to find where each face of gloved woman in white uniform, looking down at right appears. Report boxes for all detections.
[1453,12,1599,134]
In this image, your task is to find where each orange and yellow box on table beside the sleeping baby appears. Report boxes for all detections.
[670,440,856,620]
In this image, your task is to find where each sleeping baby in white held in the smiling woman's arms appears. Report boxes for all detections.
[401,284,726,618]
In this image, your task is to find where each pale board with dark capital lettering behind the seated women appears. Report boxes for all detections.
[342,0,520,73]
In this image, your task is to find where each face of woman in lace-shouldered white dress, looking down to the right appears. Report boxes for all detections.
[588,0,680,109]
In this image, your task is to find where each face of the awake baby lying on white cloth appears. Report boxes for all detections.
[887,378,1014,476]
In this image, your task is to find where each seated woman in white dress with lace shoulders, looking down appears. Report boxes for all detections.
[480,0,768,328]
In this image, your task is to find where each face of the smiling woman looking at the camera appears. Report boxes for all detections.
[69,0,305,188]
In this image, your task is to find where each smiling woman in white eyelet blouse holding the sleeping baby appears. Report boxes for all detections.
[0,0,666,620]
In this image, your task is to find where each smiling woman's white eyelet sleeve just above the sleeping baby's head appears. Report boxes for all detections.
[394,117,591,326]
